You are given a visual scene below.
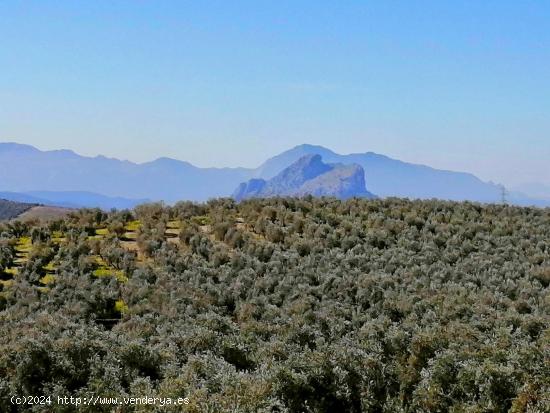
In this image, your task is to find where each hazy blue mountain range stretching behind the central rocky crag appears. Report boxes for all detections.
[0,143,550,209]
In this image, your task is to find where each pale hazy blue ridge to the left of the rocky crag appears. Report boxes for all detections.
[0,143,250,202]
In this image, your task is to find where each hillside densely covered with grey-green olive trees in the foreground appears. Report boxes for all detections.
[0,197,550,413]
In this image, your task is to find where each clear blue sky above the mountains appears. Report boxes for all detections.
[0,0,550,186]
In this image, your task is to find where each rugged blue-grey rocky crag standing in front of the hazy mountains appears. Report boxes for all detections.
[233,154,373,201]
